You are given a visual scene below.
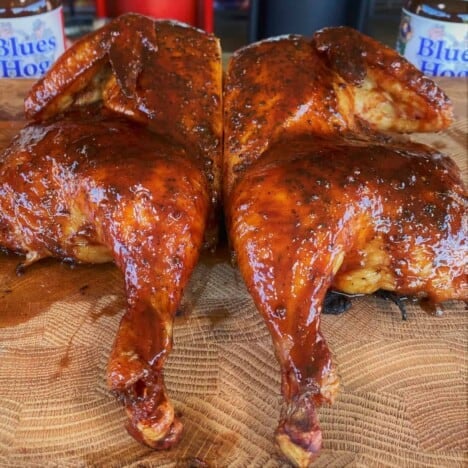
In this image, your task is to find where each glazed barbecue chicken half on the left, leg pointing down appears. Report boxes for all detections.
[0,15,222,448]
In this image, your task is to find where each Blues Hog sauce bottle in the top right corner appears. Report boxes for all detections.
[396,0,468,77]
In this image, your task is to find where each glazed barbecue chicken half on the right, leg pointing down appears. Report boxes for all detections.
[224,28,468,466]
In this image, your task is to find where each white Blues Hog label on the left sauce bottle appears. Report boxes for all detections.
[0,7,65,78]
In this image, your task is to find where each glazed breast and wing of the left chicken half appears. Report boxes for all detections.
[25,14,223,227]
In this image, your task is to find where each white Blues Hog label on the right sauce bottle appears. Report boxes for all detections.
[396,9,468,77]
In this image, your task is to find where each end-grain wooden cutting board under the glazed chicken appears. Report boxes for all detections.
[0,80,468,467]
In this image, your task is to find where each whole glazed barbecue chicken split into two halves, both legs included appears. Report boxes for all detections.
[0,15,467,466]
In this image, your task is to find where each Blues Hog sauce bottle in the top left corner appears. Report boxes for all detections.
[0,0,65,78]
